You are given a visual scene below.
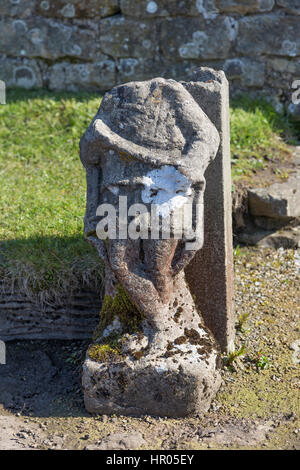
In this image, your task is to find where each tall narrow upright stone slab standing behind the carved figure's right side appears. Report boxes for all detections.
[182,67,235,351]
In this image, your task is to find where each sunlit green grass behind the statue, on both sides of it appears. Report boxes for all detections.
[0,90,296,300]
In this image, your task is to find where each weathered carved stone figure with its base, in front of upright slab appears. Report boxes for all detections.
[80,69,232,416]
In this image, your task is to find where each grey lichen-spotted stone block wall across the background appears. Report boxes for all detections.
[0,0,300,100]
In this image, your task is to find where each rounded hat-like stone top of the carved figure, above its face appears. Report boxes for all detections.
[81,78,220,183]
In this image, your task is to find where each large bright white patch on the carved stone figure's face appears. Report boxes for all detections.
[142,165,192,217]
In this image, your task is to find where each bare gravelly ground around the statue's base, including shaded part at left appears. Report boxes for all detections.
[0,247,300,450]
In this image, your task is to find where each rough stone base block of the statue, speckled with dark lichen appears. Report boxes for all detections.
[83,312,221,417]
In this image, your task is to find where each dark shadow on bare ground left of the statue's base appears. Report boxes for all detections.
[0,340,88,417]
